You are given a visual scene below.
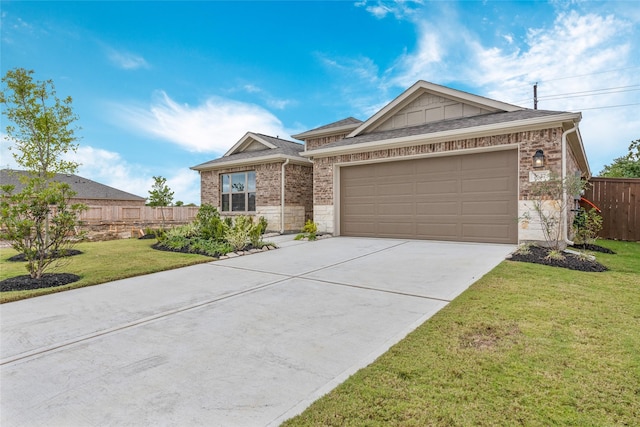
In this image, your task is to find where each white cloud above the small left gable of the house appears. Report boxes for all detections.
[113,91,289,153]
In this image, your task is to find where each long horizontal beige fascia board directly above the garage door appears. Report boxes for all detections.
[300,113,580,157]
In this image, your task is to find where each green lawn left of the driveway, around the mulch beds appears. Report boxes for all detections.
[0,239,212,303]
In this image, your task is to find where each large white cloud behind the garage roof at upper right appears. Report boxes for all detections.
[389,10,640,174]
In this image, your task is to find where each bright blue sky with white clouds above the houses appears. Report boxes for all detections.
[0,0,640,203]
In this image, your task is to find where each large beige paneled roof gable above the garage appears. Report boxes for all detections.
[348,80,524,137]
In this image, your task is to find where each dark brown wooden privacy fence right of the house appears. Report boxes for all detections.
[584,178,640,242]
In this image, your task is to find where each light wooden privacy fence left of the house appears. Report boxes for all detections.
[80,206,200,225]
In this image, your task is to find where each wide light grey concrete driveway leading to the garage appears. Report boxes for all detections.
[0,236,515,427]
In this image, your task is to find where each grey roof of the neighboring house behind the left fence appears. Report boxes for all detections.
[0,169,146,201]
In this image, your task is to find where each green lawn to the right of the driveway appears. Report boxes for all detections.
[284,241,640,427]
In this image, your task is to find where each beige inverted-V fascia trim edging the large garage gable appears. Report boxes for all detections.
[347,80,524,138]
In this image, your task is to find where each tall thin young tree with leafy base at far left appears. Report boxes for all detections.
[0,68,84,279]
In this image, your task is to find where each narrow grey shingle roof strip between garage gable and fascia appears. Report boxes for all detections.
[309,109,566,152]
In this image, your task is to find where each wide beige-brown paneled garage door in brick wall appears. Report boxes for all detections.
[340,150,518,243]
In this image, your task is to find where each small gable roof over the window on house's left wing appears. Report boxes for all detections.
[191,132,311,171]
